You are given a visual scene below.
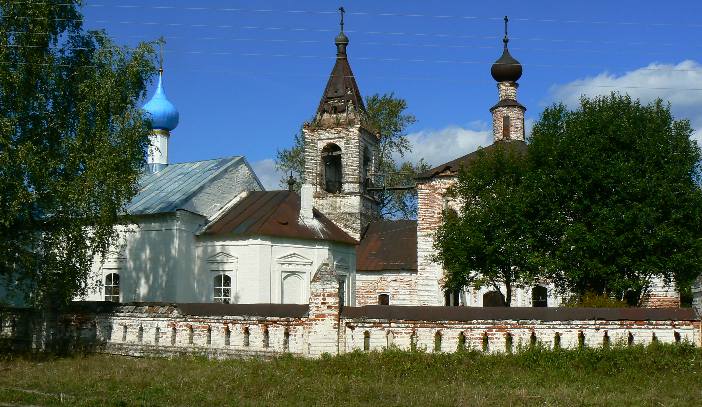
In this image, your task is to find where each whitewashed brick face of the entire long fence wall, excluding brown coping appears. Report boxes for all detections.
[0,304,700,358]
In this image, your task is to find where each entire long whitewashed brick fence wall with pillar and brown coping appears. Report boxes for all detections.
[0,302,700,358]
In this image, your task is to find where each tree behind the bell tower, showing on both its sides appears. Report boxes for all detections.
[275,93,429,218]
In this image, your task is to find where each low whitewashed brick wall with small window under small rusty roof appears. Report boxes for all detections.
[356,271,417,306]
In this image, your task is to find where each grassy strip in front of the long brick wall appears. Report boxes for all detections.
[0,345,702,406]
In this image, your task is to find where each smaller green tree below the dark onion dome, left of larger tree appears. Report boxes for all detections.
[434,143,538,306]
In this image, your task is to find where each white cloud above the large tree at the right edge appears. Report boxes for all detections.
[550,60,702,133]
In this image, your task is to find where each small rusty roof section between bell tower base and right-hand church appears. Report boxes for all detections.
[356,220,417,271]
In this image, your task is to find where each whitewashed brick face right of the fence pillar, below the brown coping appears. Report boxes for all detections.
[344,319,699,353]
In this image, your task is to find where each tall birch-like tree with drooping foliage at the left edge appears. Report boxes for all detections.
[0,0,155,307]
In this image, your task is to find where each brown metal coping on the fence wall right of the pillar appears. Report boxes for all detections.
[342,305,697,322]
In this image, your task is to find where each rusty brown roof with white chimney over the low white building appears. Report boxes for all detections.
[202,191,358,245]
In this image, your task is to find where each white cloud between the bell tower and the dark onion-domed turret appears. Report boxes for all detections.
[404,123,492,166]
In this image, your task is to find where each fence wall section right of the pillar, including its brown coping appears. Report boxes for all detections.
[343,306,700,353]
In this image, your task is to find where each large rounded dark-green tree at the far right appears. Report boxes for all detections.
[529,94,702,302]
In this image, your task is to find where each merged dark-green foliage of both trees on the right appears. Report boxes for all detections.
[436,94,702,303]
